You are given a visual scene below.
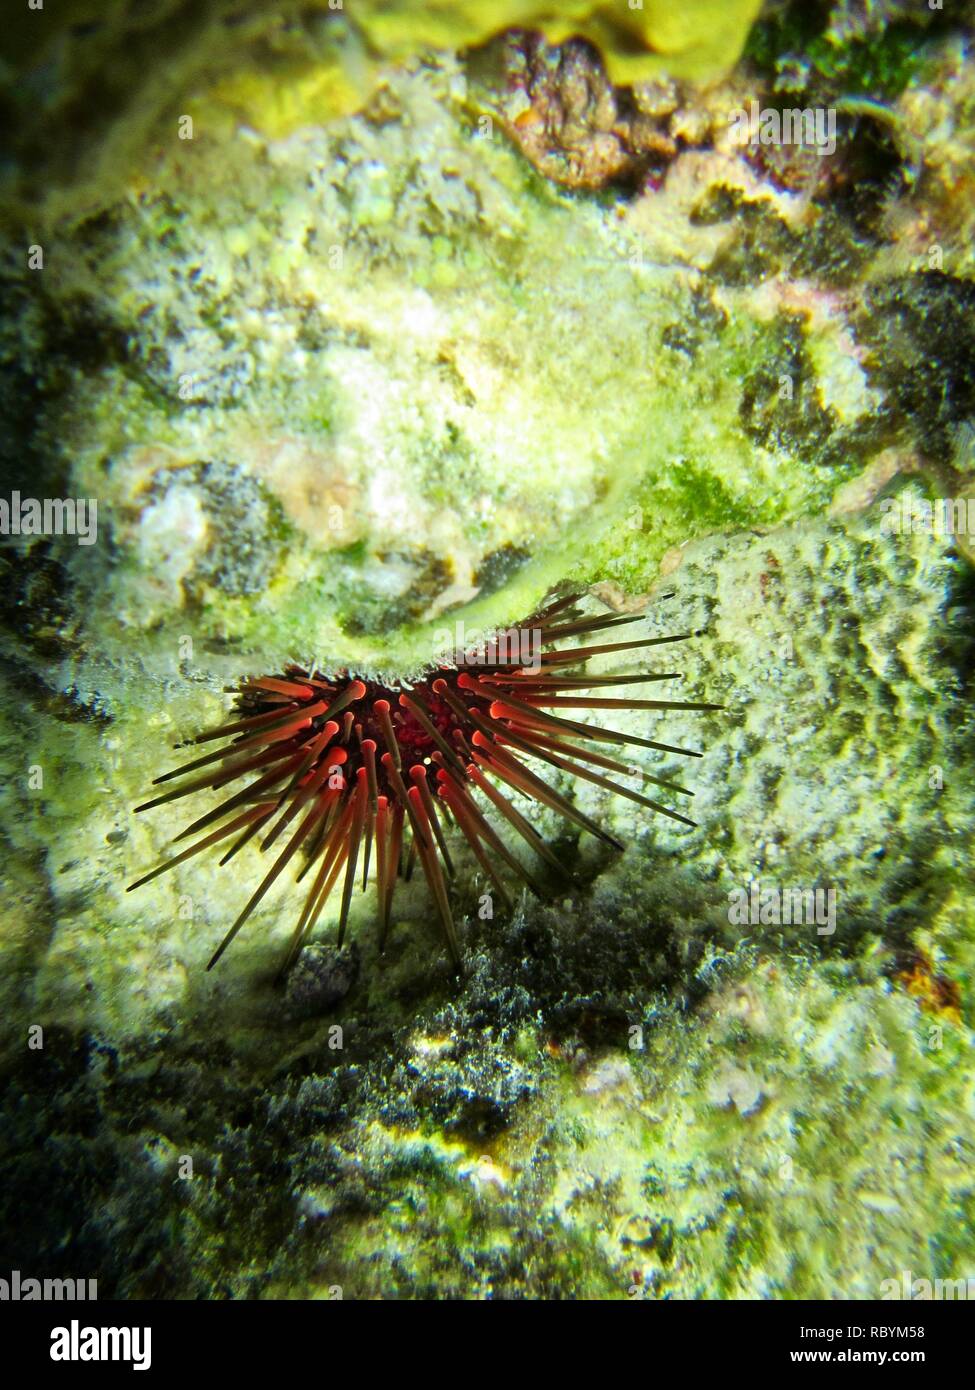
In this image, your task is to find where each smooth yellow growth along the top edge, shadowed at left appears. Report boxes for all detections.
[0,0,759,204]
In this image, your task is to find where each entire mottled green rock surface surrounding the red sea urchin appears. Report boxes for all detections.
[0,0,975,1298]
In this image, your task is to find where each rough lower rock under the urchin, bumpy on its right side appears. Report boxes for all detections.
[4,507,975,1298]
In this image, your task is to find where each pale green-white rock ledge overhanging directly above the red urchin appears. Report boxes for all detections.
[11,55,912,671]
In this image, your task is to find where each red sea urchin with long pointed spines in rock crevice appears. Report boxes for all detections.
[129,594,718,969]
